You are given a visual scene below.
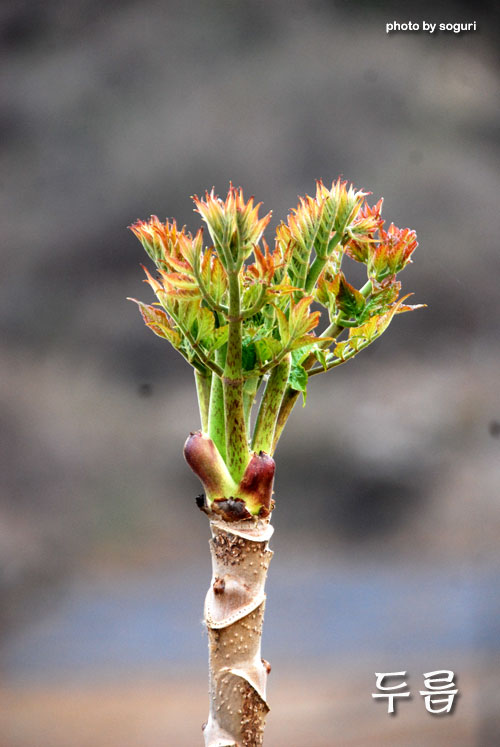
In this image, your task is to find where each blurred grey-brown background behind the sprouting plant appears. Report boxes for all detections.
[0,0,500,747]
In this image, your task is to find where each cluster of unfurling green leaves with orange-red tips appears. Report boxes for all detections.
[131,184,418,458]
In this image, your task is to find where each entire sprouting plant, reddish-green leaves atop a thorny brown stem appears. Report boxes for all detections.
[131,179,418,747]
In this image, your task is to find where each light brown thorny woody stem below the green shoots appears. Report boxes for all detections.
[203,519,273,747]
